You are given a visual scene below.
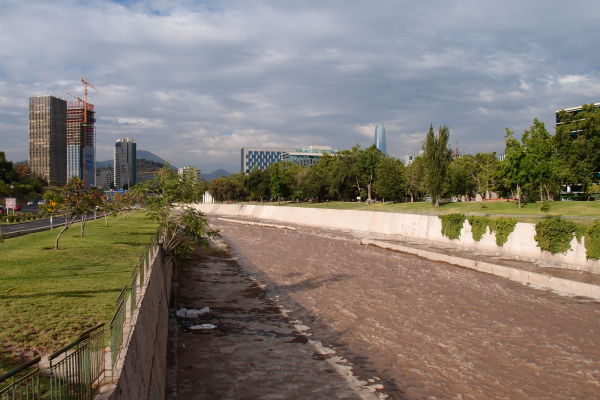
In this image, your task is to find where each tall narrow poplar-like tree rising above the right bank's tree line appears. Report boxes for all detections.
[423,125,452,207]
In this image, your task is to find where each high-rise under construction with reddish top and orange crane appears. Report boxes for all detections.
[67,101,96,185]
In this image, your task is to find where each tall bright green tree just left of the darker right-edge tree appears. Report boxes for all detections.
[521,119,559,201]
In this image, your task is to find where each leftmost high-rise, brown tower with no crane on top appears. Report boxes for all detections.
[29,96,67,185]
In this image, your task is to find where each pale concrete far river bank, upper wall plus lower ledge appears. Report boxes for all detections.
[195,204,600,300]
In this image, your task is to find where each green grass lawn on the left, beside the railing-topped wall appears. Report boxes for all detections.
[0,212,156,372]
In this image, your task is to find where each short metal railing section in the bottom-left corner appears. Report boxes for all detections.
[0,357,41,400]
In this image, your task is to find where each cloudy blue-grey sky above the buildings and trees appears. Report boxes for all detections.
[0,0,600,172]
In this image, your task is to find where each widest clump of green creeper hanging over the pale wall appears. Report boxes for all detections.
[535,216,579,254]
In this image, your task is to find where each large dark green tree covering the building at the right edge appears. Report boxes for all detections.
[554,104,600,186]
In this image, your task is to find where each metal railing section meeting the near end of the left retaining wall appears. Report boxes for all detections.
[48,324,105,400]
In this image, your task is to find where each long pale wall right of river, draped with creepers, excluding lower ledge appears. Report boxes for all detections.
[194,204,600,273]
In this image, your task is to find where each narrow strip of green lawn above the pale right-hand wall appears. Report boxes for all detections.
[274,201,600,221]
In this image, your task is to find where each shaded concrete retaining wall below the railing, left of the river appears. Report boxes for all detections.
[97,247,173,400]
